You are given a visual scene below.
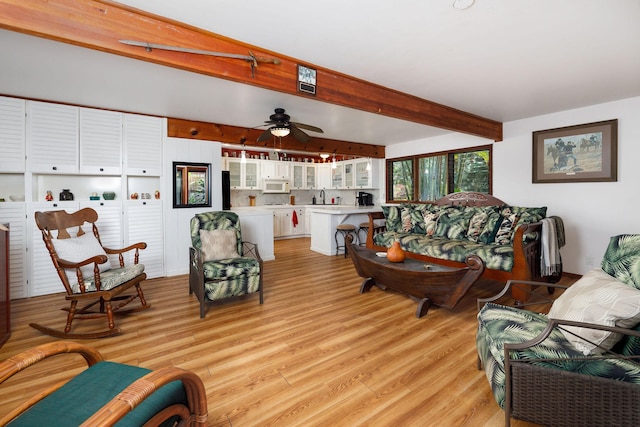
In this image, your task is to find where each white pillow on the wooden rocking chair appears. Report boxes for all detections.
[53,232,111,283]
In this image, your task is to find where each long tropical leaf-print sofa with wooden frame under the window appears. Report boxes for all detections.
[367,193,547,286]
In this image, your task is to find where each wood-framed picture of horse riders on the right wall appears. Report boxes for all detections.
[532,119,618,184]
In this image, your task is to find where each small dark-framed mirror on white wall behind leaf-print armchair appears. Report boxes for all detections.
[173,162,211,208]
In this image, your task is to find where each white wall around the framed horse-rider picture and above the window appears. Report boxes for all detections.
[386,97,640,274]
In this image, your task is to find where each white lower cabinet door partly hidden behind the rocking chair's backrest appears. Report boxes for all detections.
[27,201,80,296]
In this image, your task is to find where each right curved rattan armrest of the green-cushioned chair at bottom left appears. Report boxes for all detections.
[82,366,208,427]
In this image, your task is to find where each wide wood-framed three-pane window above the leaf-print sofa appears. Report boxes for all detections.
[387,145,492,202]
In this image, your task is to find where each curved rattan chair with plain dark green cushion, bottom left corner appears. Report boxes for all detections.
[0,341,208,427]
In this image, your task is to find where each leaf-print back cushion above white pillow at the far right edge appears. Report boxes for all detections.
[600,234,640,289]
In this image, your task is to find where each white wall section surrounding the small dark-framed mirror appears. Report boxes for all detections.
[163,138,222,278]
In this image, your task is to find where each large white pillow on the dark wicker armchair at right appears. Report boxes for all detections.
[549,268,640,355]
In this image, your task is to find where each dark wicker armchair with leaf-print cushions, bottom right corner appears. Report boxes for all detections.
[476,235,640,426]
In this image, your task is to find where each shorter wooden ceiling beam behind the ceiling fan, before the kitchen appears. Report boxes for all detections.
[167,118,385,159]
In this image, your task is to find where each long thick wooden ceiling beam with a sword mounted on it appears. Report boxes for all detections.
[0,0,502,141]
